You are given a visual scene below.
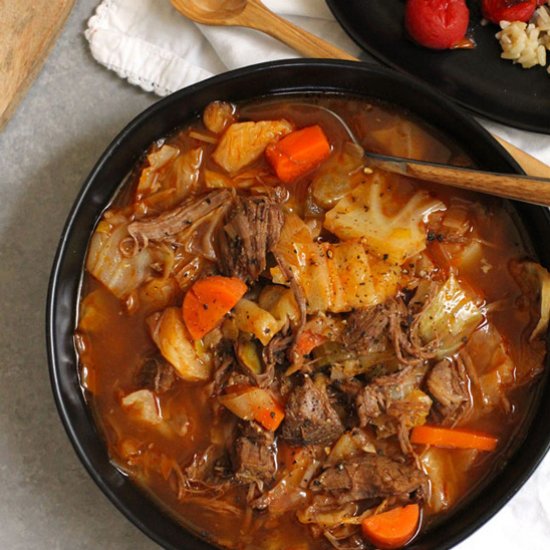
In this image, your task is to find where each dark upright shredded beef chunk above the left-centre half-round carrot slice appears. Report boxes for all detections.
[219,197,284,282]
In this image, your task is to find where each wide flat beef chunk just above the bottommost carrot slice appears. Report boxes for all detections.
[309,454,428,503]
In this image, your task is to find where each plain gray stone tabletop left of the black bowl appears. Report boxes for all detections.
[0,0,157,550]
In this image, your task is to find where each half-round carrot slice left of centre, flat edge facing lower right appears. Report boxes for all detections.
[182,275,247,340]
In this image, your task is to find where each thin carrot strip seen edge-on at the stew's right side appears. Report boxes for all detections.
[411,425,498,451]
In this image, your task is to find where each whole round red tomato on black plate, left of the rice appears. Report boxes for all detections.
[405,0,470,50]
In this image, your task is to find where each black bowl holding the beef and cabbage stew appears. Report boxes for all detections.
[47,60,550,550]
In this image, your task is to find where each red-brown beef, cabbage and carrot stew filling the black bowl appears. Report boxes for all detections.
[46,62,550,550]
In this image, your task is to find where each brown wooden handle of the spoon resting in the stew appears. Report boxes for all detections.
[365,153,550,206]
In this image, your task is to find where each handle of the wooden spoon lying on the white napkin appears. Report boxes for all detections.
[243,0,358,61]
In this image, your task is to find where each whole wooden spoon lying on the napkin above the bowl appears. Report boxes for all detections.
[171,0,357,61]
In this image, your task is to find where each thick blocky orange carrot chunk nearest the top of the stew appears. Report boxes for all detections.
[265,125,330,183]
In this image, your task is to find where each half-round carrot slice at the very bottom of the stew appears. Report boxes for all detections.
[361,504,420,549]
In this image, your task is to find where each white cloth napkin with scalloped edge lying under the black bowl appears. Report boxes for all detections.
[85,0,550,550]
